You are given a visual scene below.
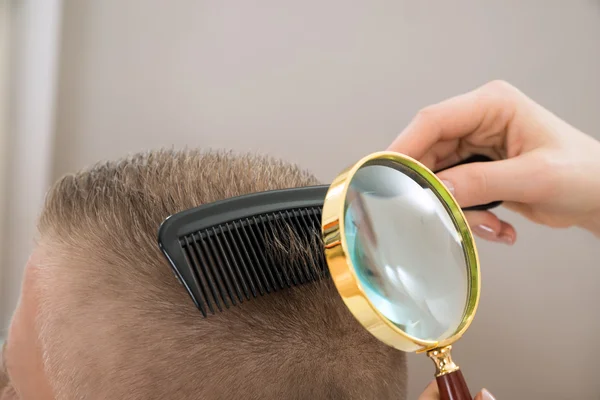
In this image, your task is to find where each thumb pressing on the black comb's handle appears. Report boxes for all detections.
[438,157,536,207]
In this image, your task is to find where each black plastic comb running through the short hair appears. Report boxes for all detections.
[158,156,501,317]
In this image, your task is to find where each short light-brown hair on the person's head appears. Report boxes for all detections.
[36,150,406,400]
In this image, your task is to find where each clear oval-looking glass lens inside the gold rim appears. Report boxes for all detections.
[344,165,469,340]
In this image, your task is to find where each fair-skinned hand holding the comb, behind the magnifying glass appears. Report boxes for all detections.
[389,81,600,244]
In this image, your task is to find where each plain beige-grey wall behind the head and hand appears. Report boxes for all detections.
[7,0,600,399]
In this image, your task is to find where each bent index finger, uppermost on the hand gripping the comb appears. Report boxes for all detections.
[388,81,518,159]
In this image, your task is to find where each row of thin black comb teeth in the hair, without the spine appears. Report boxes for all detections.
[179,207,328,317]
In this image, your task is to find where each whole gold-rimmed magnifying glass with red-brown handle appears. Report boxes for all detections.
[322,152,480,400]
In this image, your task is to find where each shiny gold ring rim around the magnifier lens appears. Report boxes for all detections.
[321,151,481,352]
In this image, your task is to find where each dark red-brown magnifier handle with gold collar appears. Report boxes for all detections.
[427,346,473,400]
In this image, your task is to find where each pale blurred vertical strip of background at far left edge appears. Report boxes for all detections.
[0,0,62,341]
